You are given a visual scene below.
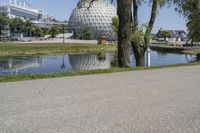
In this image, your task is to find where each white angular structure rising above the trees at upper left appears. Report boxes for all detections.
[0,0,55,39]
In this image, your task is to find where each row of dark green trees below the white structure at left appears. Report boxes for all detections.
[0,14,63,37]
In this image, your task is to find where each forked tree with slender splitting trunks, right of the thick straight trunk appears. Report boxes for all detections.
[131,0,165,66]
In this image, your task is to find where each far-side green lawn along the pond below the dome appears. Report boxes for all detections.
[0,43,116,56]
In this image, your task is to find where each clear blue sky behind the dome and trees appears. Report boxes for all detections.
[27,0,186,32]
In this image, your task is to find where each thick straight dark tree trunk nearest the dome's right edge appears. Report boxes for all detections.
[117,0,132,67]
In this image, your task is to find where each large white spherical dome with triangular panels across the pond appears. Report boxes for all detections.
[69,0,117,41]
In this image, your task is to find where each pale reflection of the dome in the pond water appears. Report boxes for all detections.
[69,52,113,71]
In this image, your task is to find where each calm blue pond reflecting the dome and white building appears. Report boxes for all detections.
[0,51,196,75]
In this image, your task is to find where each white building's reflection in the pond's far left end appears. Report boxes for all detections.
[0,57,43,74]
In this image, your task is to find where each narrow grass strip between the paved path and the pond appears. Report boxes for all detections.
[0,62,200,82]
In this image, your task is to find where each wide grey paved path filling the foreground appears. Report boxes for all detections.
[0,66,200,133]
